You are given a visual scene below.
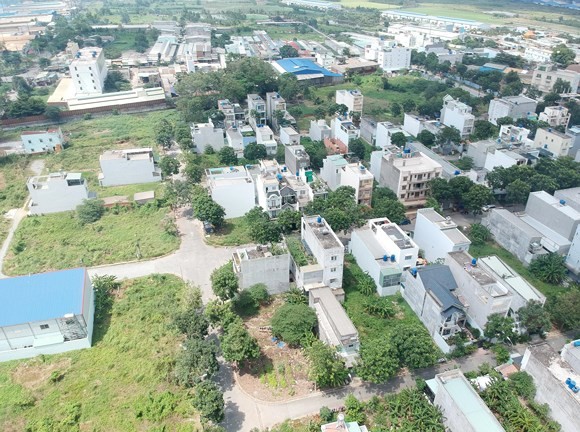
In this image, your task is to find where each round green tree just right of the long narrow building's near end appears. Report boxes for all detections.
[356,339,399,384]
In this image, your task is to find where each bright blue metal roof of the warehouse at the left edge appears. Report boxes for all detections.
[0,268,86,327]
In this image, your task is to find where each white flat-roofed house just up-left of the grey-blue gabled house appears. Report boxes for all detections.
[348,218,419,296]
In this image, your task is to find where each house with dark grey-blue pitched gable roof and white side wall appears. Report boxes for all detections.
[401,264,467,354]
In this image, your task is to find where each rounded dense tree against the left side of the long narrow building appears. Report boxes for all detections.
[271,303,318,346]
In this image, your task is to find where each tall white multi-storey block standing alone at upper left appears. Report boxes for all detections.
[69,47,107,96]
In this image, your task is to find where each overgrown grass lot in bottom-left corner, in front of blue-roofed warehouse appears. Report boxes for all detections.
[0,275,197,431]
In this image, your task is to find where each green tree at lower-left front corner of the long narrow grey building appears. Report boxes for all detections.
[306,340,348,388]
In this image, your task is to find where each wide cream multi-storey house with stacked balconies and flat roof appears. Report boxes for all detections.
[371,149,443,207]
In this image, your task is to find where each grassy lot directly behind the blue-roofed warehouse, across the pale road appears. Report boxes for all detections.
[4,205,179,275]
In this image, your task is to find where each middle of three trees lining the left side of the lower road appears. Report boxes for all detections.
[174,338,219,387]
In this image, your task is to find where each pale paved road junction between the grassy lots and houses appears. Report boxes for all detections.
[89,211,234,301]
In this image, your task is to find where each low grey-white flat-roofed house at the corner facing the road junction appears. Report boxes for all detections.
[232,243,290,295]
